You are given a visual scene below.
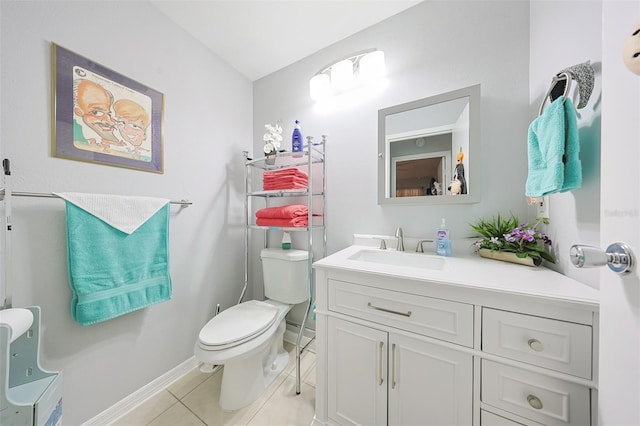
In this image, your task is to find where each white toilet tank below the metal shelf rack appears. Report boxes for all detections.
[260,248,309,304]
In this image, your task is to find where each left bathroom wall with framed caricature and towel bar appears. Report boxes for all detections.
[0,1,252,425]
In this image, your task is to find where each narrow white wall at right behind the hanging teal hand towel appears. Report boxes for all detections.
[529,1,602,288]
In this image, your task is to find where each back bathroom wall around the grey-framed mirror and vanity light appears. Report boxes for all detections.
[253,1,532,297]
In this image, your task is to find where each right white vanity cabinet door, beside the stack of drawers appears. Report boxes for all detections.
[389,334,473,426]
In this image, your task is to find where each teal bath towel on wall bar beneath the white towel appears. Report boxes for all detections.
[66,201,172,325]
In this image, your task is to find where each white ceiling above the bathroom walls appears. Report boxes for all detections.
[152,0,422,81]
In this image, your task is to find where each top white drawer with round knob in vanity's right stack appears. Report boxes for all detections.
[482,308,592,379]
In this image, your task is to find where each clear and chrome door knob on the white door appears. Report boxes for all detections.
[569,243,635,274]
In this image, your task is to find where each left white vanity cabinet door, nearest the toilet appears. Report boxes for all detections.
[327,317,387,426]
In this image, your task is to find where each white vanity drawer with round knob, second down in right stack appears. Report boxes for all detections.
[481,360,591,426]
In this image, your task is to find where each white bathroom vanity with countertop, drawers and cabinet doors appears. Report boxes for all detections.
[313,245,599,426]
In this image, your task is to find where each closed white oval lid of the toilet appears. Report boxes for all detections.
[199,300,278,346]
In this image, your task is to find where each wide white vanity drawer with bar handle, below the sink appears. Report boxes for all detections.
[329,280,473,347]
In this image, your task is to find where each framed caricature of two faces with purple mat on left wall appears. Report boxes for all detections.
[51,43,164,173]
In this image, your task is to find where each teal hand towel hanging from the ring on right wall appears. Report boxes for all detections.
[525,97,582,197]
